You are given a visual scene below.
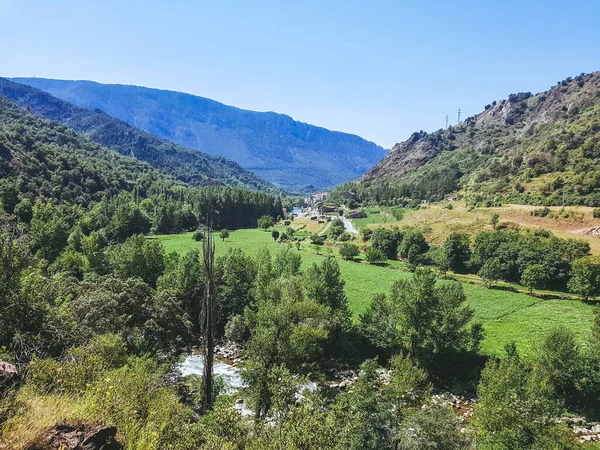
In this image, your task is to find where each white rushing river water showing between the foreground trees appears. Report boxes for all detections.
[179,355,317,416]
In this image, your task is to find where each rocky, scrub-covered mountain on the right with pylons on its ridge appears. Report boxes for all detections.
[356,72,600,206]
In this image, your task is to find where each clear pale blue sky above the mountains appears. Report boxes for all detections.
[0,0,600,148]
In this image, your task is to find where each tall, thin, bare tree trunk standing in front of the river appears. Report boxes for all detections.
[202,229,216,410]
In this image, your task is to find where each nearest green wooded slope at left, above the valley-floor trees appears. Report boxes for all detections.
[0,96,185,210]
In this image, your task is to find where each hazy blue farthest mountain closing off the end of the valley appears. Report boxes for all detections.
[12,78,386,191]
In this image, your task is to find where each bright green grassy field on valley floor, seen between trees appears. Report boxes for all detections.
[156,227,593,355]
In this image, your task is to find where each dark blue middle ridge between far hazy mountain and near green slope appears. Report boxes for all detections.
[0,78,277,192]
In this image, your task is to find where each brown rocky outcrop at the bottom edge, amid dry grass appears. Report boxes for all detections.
[27,423,123,450]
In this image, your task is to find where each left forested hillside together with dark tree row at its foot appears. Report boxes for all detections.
[0,97,281,236]
